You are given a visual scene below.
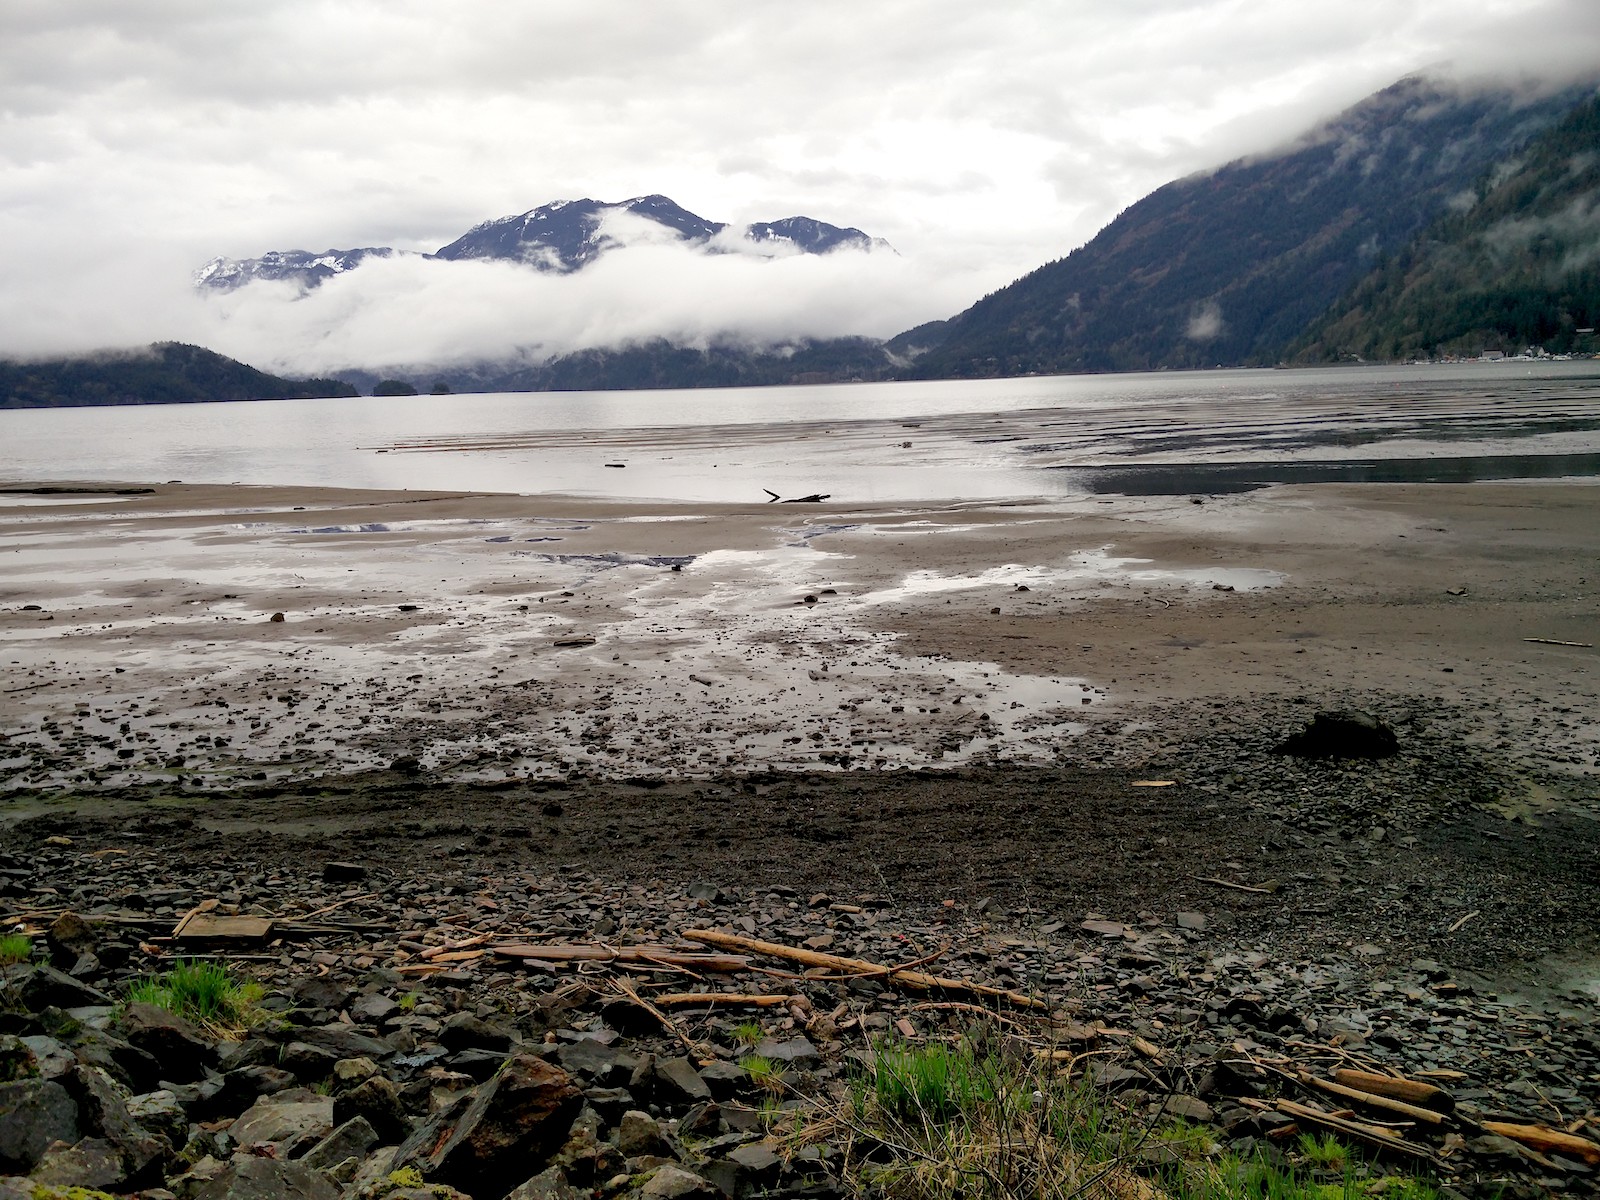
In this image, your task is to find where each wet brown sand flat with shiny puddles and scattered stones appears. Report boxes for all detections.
[0,482,1600,790]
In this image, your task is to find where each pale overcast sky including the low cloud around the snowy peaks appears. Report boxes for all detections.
[0,0,1600,370]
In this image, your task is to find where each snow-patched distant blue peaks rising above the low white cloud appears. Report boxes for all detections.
[195,195,891,291]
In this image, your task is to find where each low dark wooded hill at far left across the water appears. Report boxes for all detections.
[0,342,357,408]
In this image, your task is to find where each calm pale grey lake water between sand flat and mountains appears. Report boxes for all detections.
[0,362,1600,502]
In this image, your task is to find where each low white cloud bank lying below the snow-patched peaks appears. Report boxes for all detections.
[0,230,987,374]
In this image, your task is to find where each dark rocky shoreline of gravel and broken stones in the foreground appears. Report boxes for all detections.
[0,698,1600,1200]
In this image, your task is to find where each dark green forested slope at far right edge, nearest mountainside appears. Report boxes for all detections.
[1290,96,1600,362]
